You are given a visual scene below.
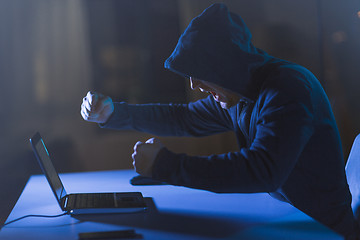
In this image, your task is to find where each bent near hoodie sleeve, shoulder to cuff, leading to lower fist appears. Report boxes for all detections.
[153,69,313,193]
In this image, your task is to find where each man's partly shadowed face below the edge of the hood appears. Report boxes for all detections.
[190,77,242,109]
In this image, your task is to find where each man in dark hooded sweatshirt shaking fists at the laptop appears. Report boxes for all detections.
[81,4,357,239]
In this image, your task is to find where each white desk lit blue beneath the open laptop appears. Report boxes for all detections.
[0,170,342,240]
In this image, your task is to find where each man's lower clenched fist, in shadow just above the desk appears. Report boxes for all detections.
[131,138,164,177]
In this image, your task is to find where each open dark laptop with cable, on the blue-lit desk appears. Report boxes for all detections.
[30,132,146,215]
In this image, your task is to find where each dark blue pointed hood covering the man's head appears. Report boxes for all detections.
[164,3,272,100]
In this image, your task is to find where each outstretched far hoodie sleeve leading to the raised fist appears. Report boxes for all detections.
[100,96,233,137]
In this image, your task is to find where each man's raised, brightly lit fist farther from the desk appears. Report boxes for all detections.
[80,92,114,123]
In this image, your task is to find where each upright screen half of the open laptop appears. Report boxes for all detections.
[30,132,66,208]
